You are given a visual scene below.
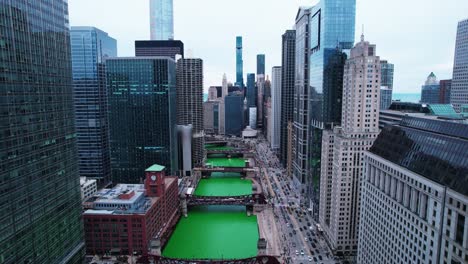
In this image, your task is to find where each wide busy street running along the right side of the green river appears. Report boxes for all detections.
[248,137,339,264]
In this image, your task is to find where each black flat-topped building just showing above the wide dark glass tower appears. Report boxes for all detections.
[135,40,184,60]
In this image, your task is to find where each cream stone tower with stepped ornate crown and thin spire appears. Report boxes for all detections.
[319,36,381,255]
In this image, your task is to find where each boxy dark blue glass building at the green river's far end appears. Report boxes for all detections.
[224,94,244,137]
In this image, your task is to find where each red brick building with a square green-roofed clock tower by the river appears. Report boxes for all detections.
[83,165,179,255]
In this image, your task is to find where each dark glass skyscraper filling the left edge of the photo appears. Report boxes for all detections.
[0,0,84,264]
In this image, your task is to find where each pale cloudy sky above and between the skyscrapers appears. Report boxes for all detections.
[68,0,468,93]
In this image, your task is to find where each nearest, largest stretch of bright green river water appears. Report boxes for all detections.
[162,206,259,260]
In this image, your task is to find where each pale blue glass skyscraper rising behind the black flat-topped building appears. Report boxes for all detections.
[150,0,174,40]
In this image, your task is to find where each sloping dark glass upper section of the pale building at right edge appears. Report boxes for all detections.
[370,117,468,195]
